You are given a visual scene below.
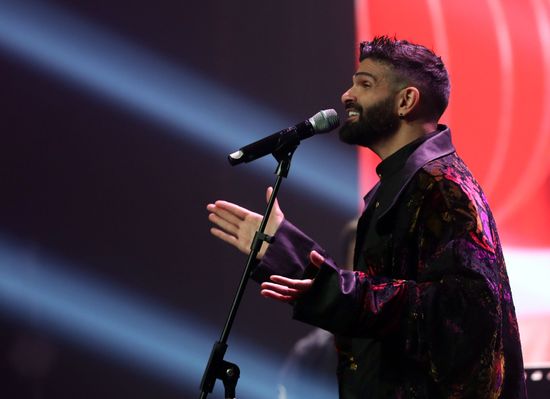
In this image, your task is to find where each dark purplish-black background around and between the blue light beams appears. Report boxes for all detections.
[0,0,358,398]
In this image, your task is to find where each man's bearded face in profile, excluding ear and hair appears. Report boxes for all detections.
[339,59,400,148]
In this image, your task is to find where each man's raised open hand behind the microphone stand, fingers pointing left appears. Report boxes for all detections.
[206,187,285,259]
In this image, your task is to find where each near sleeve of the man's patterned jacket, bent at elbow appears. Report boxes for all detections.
[294,178,504,397]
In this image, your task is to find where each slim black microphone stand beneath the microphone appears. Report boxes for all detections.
[200,140,300,399]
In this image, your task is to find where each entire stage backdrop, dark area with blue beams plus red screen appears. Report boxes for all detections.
[0,0,550,399]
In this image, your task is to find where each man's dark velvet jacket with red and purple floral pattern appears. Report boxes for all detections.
[253,126,526,399]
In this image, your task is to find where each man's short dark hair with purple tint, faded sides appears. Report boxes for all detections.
[359,36,450,120]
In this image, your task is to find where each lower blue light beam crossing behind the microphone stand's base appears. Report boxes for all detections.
[0,238,331,399]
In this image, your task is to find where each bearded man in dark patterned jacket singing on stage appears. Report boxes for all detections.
[208,37,526,399]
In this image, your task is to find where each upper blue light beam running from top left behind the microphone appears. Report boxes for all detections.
[0,0,358,215]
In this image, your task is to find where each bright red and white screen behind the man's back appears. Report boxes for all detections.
[356,0,550,363]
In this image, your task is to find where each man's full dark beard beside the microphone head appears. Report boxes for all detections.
[339,96,400,148]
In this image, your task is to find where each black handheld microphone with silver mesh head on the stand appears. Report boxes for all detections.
[227,109,340,166]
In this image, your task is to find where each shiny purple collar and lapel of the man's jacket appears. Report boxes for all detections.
[365,125,456,219]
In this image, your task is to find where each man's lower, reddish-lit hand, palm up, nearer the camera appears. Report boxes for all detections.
[260,251,325,303]
